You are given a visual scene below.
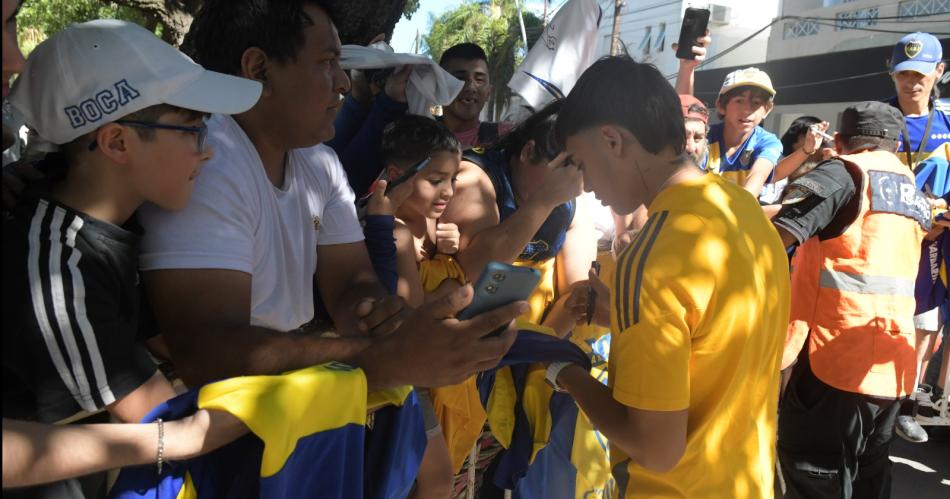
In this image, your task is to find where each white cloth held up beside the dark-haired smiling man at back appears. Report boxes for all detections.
[340,42,465,116]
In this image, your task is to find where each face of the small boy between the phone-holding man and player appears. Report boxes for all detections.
[402,151,461,219]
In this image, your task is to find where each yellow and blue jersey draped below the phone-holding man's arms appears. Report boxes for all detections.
[110,363,426,499]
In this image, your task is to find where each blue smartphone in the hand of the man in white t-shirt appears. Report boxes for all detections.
[457,261,541,336]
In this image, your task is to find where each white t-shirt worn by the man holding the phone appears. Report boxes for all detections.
[139,115,363,331]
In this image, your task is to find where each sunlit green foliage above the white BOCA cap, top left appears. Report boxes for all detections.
[17,0,154,54]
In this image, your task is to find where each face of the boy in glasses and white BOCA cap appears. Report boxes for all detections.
[131,113,214,210]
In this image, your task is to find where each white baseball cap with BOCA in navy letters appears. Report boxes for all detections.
[9,20,262,144]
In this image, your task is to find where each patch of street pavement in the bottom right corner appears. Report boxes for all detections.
[891,426,950,499]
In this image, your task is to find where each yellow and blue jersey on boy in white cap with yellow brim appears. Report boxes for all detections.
[700,123,782,185]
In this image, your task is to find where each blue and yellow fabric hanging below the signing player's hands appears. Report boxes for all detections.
[478,325,610,499]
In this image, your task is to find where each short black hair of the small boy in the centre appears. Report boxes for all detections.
[379,114,462,170]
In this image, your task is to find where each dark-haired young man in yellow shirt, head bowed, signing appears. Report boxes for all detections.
[547,56,789,497]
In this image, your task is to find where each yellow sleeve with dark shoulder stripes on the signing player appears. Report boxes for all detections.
[609,211,714,411]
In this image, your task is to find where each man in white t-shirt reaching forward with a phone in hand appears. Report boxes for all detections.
[140,0,526,389]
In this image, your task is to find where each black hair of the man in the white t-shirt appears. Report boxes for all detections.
[181,0,333,76]
